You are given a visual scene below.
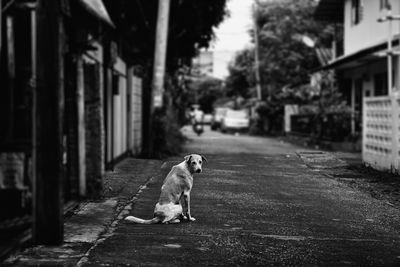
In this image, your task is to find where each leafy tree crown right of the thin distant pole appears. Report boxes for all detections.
[253,0,333,97]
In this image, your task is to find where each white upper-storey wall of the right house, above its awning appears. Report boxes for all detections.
[344,0,400,55]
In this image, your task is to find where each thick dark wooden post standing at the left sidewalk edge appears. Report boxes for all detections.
[33,0,64,245]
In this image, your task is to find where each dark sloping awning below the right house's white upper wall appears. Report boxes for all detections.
[317,38,399,70]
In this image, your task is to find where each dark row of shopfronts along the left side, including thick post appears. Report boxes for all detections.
[0,0,142,248]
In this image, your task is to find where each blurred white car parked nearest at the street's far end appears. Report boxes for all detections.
[221,109,250,132]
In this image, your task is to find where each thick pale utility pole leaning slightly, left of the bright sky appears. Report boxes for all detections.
[144,0,170,156]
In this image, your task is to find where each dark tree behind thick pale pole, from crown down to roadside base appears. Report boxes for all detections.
[104,0,227,157]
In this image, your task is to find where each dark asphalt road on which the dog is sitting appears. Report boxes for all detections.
[85,126,400,266]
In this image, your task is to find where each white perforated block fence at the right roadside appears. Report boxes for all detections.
[362,96,400,173]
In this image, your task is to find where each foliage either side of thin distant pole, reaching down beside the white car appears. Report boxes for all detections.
[226,0,340,133]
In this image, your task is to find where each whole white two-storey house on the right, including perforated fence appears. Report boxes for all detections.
[315,0,400,172]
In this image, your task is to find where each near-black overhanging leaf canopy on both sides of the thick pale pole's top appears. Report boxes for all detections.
[104,0,226,69]
